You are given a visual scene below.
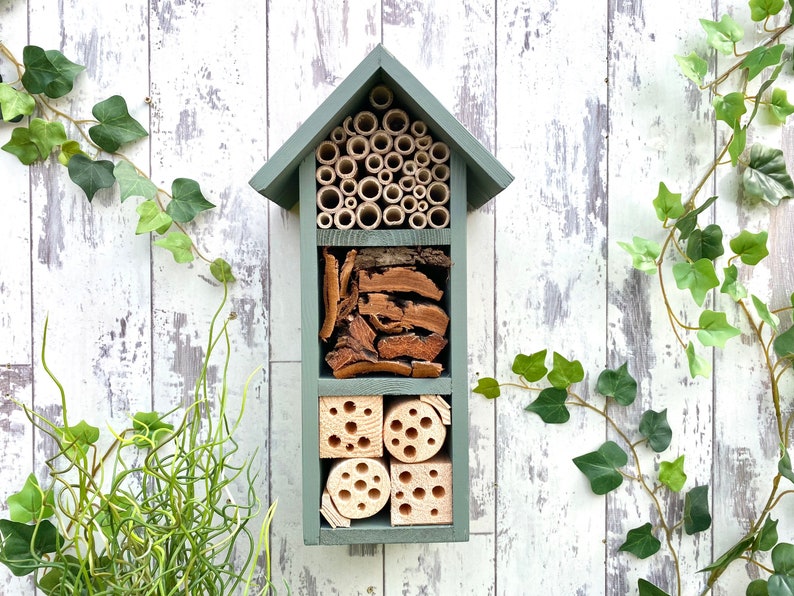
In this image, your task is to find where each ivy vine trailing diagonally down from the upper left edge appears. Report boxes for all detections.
[0,42,234,282]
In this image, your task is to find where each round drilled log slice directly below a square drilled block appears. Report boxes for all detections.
[325,457,391,519]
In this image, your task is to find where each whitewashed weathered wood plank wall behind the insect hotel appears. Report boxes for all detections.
[0,0,794,596]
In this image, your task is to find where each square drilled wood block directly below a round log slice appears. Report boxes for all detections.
[391,453,452,526]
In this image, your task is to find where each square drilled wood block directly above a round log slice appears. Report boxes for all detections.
[320,395,383,458]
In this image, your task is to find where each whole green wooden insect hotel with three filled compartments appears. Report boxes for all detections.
[251,46,512,544]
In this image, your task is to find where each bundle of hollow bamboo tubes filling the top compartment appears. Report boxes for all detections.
[315,84,450,230]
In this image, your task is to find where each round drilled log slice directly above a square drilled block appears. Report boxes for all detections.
[383,399,447,463]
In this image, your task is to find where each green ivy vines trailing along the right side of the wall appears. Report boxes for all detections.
[474,0,794,596]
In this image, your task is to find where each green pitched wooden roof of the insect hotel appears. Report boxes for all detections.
[244,44,513,209]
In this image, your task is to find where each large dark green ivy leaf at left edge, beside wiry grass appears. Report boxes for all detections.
[0,519,63,576]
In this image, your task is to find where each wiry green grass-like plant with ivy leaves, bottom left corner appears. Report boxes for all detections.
[0,284,276,596]
